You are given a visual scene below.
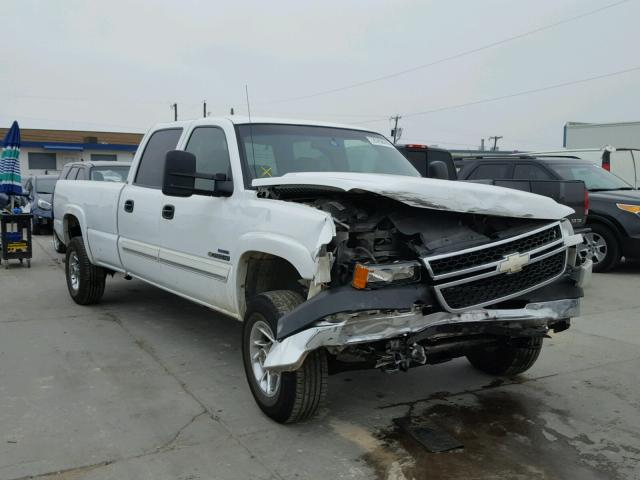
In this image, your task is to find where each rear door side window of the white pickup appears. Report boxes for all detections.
[133,128,182,188]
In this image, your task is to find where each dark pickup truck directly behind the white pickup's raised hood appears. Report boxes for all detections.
[396,144,589,232]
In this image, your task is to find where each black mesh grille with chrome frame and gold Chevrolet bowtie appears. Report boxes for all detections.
[423,222,567,312]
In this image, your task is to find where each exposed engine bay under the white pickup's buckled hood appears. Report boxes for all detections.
[274,190,549,286]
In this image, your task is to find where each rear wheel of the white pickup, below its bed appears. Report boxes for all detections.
[65,237,106,305]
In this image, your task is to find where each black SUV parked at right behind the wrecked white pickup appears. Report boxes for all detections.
[456,156,640,272]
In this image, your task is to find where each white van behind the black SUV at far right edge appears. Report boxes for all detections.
[528,145,640,189]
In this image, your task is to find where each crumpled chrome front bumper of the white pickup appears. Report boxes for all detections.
[264,262,591,371]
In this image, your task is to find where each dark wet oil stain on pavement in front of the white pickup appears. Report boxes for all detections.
[363,391,640,480]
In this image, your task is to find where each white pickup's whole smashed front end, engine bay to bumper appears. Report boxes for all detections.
[262,186,591,372]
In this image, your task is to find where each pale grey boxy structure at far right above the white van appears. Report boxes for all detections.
[562,122,640,148]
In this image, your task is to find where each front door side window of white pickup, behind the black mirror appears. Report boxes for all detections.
[185,127,231,190]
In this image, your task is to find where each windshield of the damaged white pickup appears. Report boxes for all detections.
[238,124,420,183]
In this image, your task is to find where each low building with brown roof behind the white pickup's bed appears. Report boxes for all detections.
[0,128,142,178]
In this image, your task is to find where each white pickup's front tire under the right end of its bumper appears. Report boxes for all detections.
[467,337,542,376]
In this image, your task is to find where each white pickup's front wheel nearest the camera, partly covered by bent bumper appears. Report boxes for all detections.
[242,290,328,423]
